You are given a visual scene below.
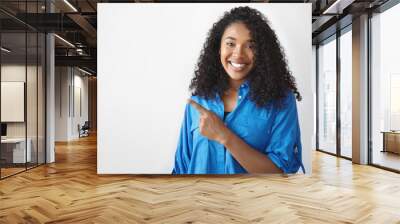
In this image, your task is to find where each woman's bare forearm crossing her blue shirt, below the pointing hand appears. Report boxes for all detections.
[221,129,282,173]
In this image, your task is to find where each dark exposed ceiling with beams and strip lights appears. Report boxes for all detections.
[0,0,394,73]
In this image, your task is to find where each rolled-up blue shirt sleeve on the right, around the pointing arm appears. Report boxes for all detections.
[266,93,305,173]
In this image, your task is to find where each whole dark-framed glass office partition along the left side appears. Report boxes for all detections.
[0,1,46,179]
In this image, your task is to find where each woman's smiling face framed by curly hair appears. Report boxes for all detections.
[220,22,254,86]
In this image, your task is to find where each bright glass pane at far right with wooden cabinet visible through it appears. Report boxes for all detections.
[370,4,400,171]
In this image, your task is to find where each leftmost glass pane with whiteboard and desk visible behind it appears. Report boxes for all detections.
[0,32,27,178]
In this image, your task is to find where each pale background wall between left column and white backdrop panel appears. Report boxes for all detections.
[55,67,88,141]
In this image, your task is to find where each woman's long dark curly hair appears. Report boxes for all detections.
[189,6,301,107]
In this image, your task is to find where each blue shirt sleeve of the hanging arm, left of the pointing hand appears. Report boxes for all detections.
[172,104,193,174]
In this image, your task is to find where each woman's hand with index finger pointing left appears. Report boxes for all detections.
[188,99,230,145]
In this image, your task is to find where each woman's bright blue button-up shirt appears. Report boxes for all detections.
[172,82,304,174]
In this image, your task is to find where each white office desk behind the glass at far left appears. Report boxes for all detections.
[1,138,32,163]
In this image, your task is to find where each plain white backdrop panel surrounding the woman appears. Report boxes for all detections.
[97,3,315,174]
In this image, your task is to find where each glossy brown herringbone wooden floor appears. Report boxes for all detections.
[0,134,400,224]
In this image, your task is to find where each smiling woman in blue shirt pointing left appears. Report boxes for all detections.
[173,7,304,174]
